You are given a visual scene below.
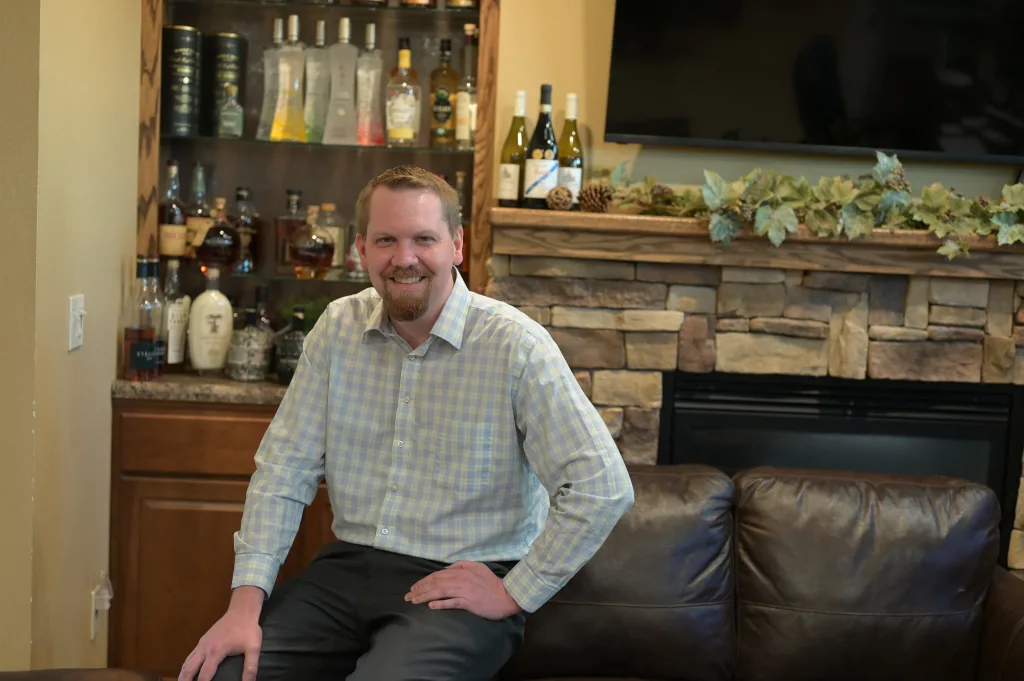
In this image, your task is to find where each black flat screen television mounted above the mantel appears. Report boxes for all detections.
[604,0,1024,165]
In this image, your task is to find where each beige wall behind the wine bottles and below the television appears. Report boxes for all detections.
[495,0,1016,196]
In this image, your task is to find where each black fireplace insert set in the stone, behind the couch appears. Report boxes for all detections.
[658,372,1024,566]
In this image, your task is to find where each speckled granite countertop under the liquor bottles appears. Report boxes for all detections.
[111,374,288,405]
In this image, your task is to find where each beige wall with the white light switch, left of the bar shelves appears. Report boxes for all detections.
[0,0,141,669]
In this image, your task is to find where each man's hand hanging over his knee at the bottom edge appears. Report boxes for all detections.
[178,587,264,681]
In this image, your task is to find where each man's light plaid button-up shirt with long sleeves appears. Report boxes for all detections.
[232,275,633,611]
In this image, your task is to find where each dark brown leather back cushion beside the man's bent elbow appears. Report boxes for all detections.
[501,465,735,681]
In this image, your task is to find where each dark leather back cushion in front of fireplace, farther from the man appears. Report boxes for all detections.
[735,468,999,681]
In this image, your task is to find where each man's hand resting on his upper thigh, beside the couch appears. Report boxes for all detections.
[406,560,521,620]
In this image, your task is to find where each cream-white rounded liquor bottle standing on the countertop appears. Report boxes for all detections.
[188,267,233,376]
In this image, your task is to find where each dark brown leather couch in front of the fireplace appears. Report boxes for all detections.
[500,466,1024,681]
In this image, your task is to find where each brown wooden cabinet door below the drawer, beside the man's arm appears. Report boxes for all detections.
[109,478,316,677]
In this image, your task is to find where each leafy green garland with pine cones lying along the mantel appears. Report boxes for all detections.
[573,152,1024,260]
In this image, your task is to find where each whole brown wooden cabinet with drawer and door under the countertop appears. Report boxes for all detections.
[108,399,333,677]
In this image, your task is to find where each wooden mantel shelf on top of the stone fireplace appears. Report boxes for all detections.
[489,208,1024,280]
